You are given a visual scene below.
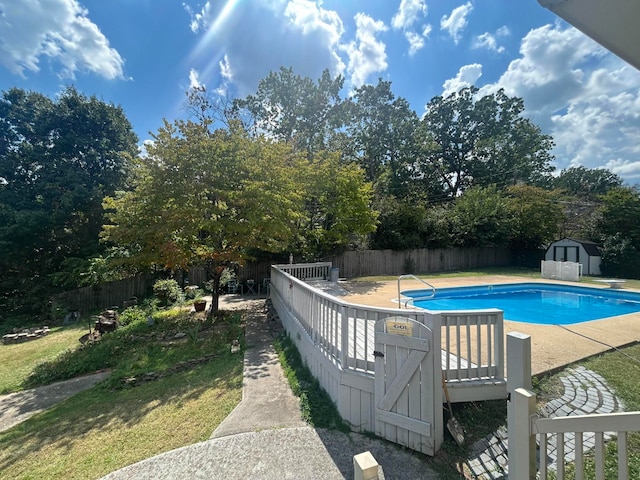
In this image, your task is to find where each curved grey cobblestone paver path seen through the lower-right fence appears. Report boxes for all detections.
[465,366,624,480]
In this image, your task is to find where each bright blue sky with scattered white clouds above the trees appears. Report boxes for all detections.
[0,0,640,184]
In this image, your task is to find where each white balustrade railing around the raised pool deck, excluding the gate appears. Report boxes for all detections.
[271,264,504,382]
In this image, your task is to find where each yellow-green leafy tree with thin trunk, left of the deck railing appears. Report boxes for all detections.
[103,121,303,313]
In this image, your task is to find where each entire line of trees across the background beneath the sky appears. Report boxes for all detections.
[0,68,640,316]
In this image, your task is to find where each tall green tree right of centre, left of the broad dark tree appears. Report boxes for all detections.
[342,79,442,249]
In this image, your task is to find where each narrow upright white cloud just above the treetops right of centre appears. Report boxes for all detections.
[344,13,387,88]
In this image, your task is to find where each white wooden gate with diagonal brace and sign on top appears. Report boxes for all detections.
[374,317,443,455]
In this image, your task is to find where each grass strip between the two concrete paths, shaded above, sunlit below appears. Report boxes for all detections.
[0,355,242,479]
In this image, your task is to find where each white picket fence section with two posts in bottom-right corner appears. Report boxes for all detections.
[507,333,640,480]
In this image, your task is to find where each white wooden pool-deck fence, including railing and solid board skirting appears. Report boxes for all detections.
[271,264,506,455]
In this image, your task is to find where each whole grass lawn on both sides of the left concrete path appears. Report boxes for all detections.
[0,309,243,479]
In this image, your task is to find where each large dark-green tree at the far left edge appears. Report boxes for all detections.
[0,87,137,316]
